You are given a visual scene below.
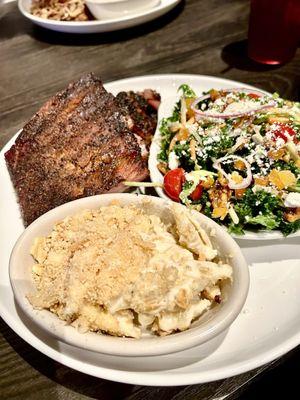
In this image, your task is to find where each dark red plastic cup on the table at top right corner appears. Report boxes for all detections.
[248,0,300,65]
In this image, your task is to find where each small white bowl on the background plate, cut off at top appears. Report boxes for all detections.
[85,0,160,20]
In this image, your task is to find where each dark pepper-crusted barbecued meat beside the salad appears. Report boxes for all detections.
[5,74,160,225]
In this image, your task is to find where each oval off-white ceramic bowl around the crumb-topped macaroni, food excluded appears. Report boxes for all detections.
[9,193,249,358]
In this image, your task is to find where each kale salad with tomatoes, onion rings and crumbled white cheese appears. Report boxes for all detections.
[157,85,300,236]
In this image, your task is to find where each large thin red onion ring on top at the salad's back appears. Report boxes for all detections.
[191,88,276,120]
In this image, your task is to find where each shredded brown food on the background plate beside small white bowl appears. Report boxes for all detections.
[30,0,94,21]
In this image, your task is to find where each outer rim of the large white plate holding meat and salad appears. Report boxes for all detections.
[0,74,300,386]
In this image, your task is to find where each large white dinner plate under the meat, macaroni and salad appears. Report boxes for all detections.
[0,75,300,386]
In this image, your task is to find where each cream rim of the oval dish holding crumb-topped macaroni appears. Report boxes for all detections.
[9,193,250,357]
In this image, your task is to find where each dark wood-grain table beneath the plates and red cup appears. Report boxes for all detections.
[0,0,300,400]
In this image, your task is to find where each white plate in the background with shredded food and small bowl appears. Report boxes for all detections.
[18,0,180,33]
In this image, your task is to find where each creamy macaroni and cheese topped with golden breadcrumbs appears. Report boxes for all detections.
[28,203,232,338]
